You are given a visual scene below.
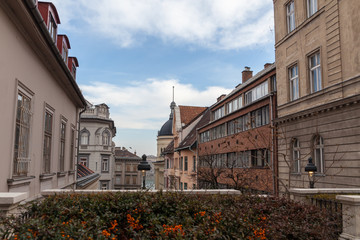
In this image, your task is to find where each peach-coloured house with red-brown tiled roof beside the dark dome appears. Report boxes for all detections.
[162,106,207,190]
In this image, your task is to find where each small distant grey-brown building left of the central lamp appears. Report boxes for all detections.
[114,147,142,190]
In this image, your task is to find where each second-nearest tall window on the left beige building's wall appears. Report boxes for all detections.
[42,110,53,173]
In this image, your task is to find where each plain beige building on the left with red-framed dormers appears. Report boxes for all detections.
[0,0,86,200]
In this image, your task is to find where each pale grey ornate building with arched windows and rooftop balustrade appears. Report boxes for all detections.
[78,103,116,189]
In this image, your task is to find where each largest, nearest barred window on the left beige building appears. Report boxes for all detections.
[14,91,32,176]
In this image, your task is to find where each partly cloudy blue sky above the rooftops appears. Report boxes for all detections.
[52,0,275,156]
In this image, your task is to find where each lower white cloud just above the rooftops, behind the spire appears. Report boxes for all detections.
[80,79,231,130]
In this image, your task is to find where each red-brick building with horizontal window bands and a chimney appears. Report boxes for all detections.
[197,64,277,193]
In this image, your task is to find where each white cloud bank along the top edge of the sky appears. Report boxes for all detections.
[53,0,273,50]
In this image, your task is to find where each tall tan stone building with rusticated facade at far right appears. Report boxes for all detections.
[274,0,360,192]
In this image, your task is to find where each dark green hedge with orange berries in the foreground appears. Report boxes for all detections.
[0,192,341,240]
